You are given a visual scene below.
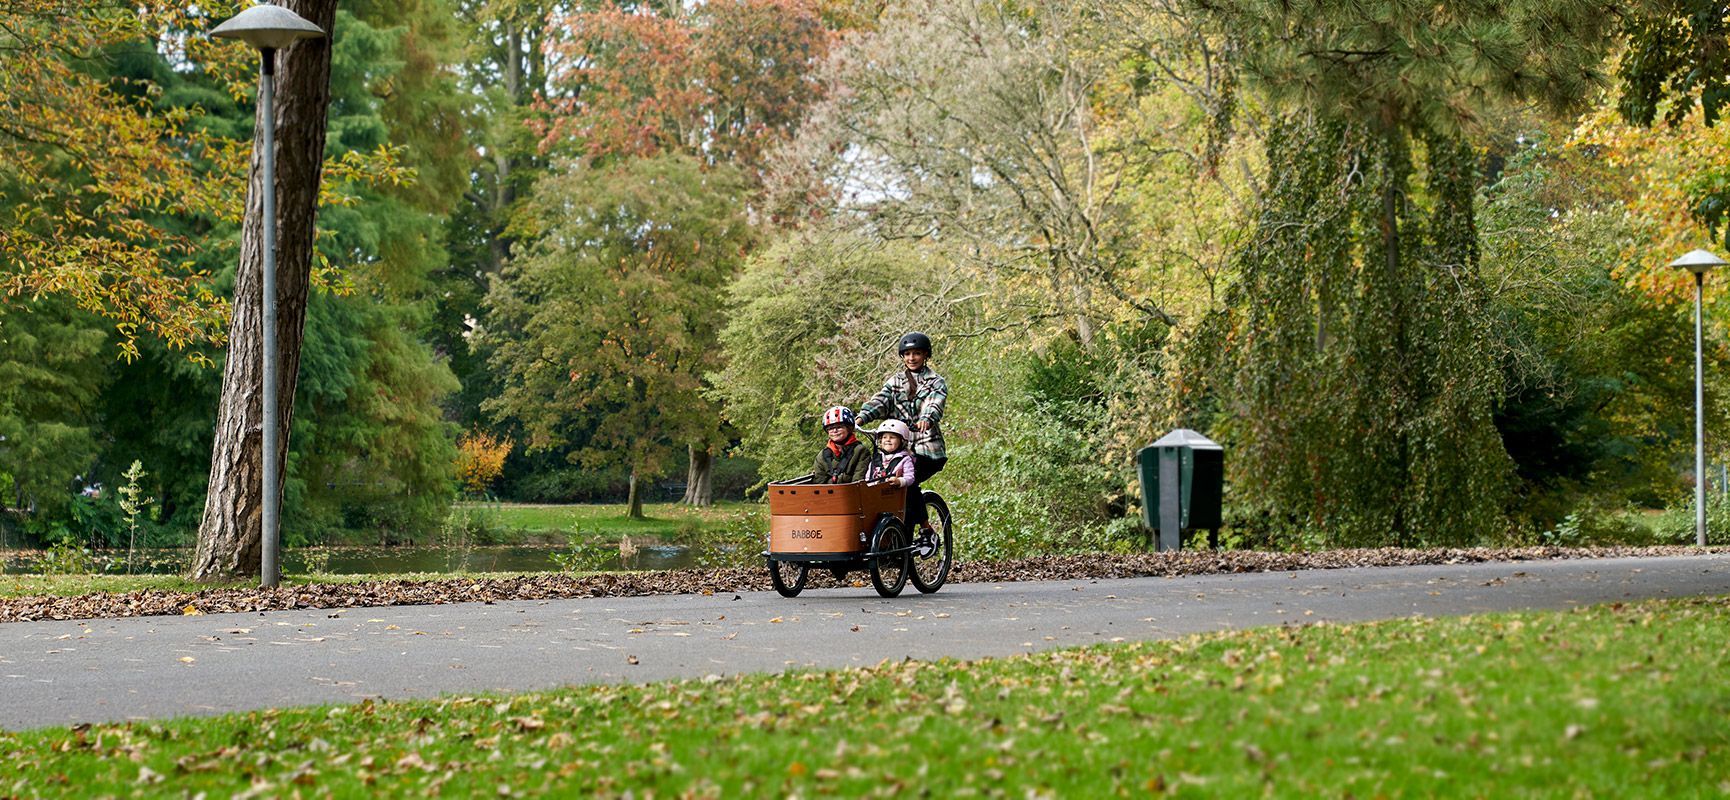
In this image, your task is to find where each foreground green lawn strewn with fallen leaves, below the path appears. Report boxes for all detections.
[0,599,1730,798]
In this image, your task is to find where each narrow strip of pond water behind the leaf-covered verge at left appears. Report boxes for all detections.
[0,544,697,575]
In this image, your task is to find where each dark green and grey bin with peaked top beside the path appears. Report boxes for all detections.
[1137,428,1225,552]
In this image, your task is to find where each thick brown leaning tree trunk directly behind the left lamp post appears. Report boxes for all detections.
[190,0,336,580]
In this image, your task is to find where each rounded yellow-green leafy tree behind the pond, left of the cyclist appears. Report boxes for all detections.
[479,154,751,516]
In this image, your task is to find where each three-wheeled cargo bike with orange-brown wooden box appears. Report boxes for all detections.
[765,476,955,597]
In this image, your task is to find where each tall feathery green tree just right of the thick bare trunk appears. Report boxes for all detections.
[284,0,474,542]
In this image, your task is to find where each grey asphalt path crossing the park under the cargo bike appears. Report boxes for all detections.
[0,554,1730,729]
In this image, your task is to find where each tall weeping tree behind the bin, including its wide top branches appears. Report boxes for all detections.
[1180,0,1609,544]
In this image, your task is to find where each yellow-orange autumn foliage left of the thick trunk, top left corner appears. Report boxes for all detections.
[0,0,249,355]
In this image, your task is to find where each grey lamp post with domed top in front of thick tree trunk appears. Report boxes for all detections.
[211,3,324,587]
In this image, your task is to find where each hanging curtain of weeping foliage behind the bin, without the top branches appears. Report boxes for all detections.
[1178,116,1512,547]
